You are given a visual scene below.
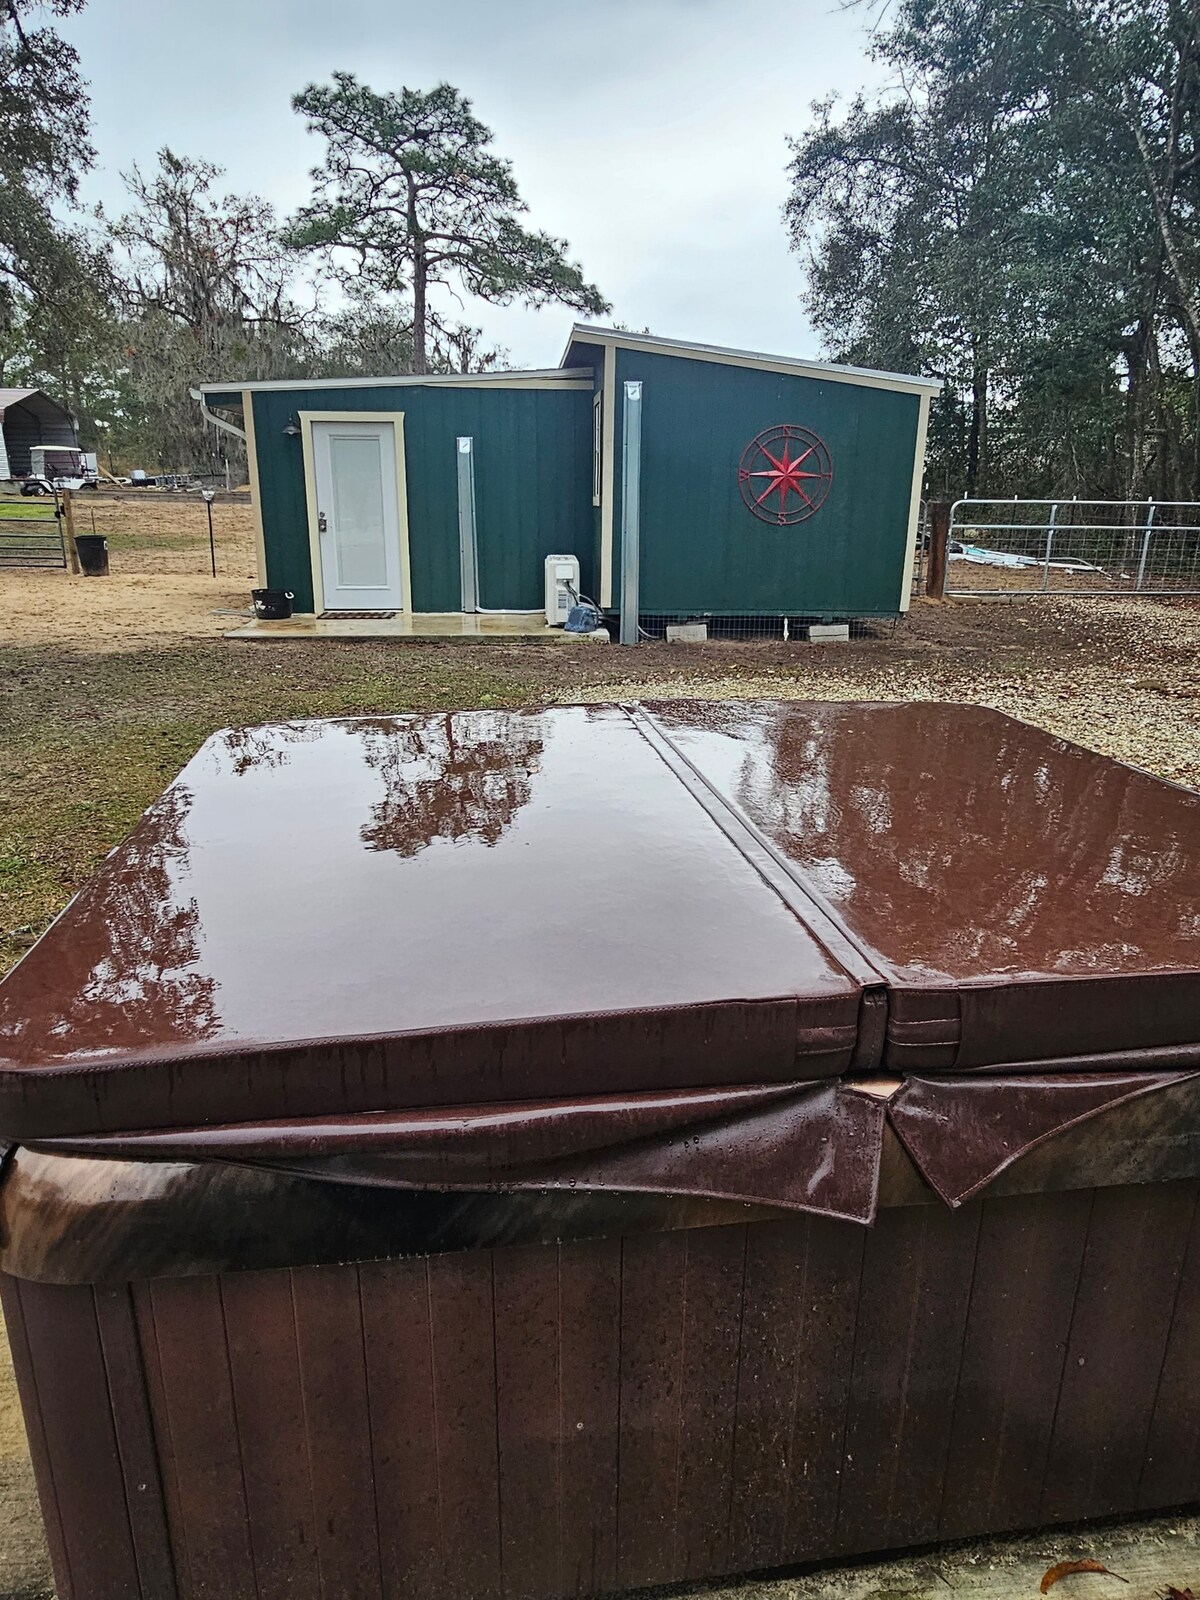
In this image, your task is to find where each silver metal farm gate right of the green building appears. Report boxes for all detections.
[946,499,1200,597]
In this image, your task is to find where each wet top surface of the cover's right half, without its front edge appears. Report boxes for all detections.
[648,701,1200,979]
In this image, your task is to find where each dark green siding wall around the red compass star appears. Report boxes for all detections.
[613,350,920,616]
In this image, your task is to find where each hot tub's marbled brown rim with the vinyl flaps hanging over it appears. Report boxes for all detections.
[0,1072,1200,1283]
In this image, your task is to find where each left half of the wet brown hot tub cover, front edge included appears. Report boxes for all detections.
[0,709,858,1081]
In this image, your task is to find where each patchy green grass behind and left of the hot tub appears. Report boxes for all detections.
[0,643,566,971]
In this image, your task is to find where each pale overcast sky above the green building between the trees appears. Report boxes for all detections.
[58,0,878,366]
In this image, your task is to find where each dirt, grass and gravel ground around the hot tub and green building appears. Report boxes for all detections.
[0,540,1200,1600]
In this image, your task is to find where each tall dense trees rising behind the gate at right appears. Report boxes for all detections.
[787,0,1200,498]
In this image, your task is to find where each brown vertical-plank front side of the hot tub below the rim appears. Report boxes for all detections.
[14,1181,1200,1600]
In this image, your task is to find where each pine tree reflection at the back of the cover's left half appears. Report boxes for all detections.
[342,712,542,856]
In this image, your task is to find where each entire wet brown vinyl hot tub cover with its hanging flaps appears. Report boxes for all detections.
[0,701,1200,1221]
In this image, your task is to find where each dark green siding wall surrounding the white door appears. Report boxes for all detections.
[253,386,594,611]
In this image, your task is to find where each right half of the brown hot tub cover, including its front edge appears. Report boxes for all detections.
[645,702,1200,1072]
